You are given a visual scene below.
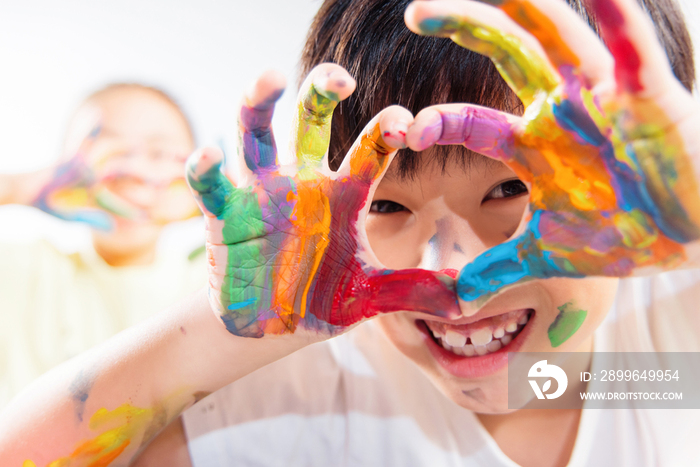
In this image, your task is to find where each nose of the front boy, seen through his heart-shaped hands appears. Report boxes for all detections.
[419,216,489,271]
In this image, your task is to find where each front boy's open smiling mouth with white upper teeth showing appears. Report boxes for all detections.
[418,308,534,358]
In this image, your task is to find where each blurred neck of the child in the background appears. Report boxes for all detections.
[92,226,161,267]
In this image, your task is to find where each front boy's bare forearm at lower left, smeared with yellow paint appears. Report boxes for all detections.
[0,291,304,465]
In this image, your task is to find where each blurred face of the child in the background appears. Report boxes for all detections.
[67,89,198,228]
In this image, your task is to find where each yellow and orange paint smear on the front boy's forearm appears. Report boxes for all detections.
[24,404,165,467]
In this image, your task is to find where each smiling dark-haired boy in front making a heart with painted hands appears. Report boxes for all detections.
[0,0,698,466]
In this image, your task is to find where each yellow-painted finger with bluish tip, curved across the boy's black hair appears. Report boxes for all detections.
[405,0,560,106]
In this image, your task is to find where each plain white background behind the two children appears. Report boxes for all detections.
[0,0,700,251]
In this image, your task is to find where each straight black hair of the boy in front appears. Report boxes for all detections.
[300,0,695,176]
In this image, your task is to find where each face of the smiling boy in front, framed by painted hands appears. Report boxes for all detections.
[367,149,617,413]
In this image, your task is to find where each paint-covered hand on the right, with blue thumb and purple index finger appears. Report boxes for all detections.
[406,0,700,301]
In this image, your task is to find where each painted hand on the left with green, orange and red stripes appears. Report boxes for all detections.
[187,64,460,338]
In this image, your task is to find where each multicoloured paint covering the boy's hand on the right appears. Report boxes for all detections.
[420,0,700,301]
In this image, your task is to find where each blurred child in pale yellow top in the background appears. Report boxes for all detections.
[0,84,206,407]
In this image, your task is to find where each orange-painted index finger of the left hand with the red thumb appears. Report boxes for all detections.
[337,105,413,183]
